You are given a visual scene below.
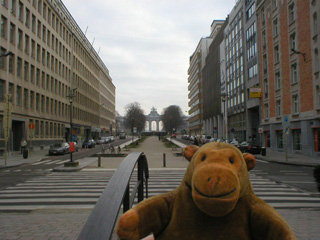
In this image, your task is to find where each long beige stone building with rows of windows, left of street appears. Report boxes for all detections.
[0,0,115,150]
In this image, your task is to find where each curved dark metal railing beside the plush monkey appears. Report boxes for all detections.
[78,152,149,240]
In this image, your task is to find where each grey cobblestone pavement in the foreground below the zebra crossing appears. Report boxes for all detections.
[0,209,320,240]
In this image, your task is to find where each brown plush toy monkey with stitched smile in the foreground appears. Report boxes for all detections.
[117,143,295,240]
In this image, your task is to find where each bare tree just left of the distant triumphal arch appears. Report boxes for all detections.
[124,102,146,132]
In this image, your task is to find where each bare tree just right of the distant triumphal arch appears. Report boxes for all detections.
[161,105,183,134]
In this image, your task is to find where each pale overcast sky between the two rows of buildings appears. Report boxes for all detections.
[63,0,236,115]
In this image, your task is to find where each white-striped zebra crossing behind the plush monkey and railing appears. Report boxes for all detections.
[0,168,320,212]
